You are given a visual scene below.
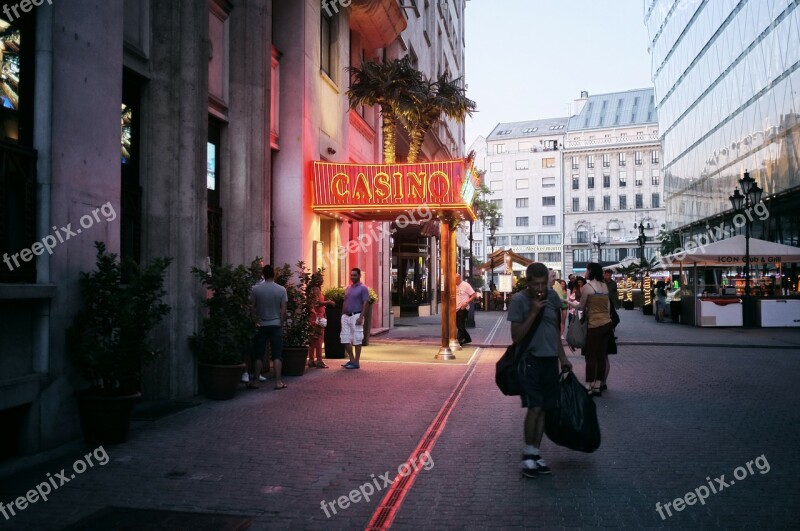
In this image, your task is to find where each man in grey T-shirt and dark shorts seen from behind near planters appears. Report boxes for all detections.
[252,264,289,389]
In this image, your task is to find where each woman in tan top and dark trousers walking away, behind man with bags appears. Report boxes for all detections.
[577,262,613,396]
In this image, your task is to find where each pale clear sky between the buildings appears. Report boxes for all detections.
[464,0,653,144]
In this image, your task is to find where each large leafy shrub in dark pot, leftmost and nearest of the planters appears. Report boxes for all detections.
[66,242,172,444]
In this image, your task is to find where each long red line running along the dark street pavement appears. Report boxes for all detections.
[365,317,503,531]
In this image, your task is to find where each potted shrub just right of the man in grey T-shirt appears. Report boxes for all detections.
[275,261,322,376]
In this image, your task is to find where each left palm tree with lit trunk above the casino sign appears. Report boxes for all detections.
[347,56,424,164]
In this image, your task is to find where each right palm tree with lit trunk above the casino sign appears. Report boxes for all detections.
[401,72,475,163]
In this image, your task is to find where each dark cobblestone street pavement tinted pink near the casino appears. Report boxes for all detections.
[0,311,800,529]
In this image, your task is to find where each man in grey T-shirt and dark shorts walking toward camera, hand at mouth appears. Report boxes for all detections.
[508,262,572,478]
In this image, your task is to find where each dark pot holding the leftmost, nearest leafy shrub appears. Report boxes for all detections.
[75,389,142,444]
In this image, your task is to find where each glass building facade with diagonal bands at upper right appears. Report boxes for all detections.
[644,0,800,246]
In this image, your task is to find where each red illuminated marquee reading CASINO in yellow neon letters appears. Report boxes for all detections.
[312,160,478,219]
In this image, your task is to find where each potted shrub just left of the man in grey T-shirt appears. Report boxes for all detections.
[189,264,256,400]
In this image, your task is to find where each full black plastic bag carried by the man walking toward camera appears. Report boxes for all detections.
[544,371,600,452]
